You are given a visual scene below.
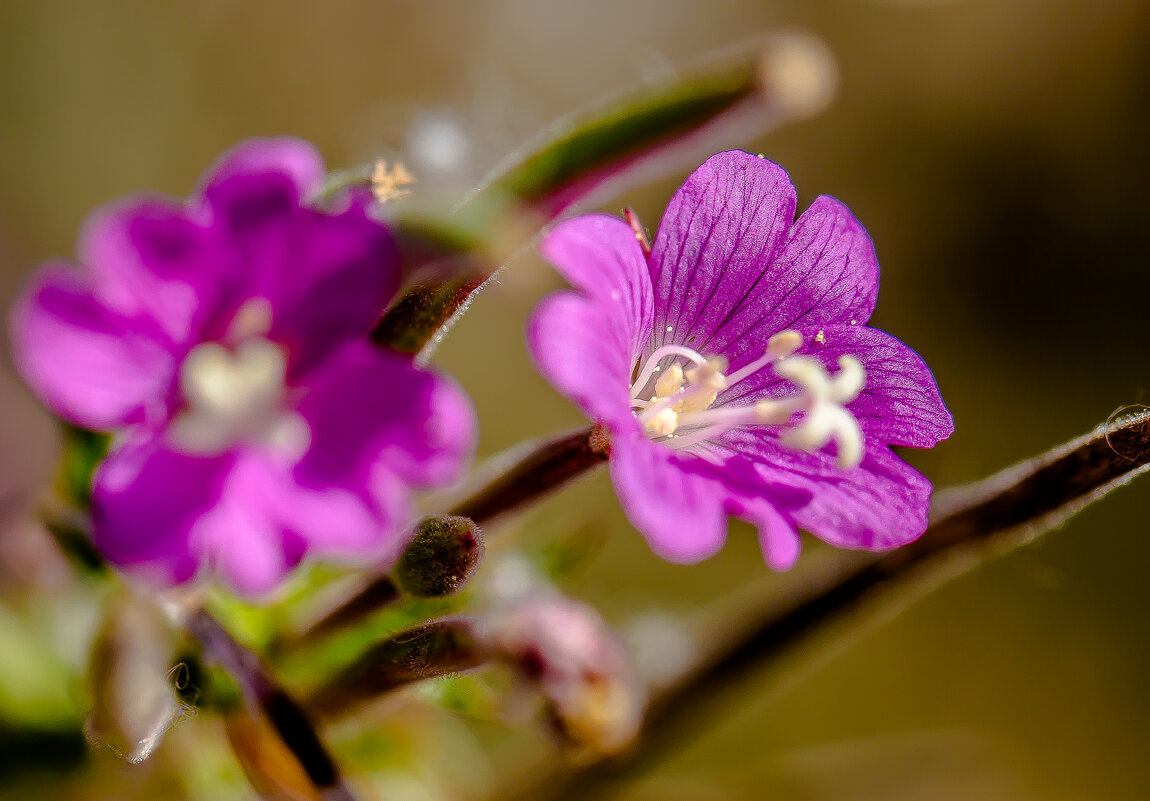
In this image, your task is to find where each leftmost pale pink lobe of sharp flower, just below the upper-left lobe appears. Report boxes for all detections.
[527,292,638,432]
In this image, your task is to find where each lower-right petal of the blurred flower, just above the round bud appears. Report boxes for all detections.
[294,342,475,494]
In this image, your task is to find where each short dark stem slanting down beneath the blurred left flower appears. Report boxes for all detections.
[184,609,354,801]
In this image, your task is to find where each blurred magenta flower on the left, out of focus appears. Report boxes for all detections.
[12,139,474,593]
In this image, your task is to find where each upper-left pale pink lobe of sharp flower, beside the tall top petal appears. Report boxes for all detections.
[539,214,653,364]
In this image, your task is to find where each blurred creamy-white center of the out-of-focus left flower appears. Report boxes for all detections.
[170,300,311,461]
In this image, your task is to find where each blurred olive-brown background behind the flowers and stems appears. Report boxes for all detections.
[0,0,1150,801]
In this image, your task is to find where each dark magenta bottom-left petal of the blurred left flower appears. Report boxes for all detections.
[92,434,232,585]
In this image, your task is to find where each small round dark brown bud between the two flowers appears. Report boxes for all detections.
[392,515,483,598]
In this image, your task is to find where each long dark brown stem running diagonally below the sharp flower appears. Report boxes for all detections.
[510,413,1150,801]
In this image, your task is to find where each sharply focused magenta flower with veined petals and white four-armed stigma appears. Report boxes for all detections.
[528,152,953,570]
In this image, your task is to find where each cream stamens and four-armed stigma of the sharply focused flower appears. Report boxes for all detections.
[631,331,866,469]
